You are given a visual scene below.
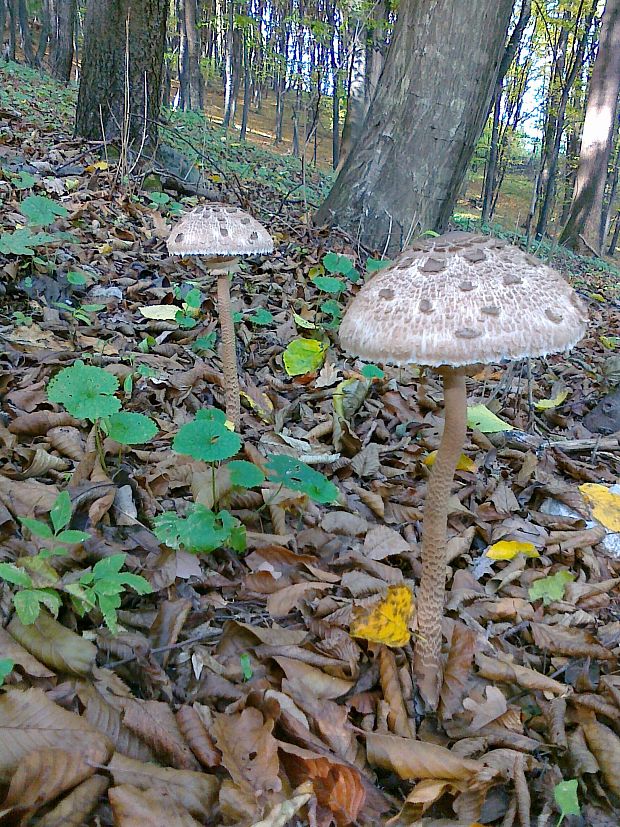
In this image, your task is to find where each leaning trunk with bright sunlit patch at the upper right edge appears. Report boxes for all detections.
[560,0,620,255]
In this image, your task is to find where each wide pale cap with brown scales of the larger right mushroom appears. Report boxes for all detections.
[339,232,587,367]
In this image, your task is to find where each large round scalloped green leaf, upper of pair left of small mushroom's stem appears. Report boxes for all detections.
[47,360,121,422]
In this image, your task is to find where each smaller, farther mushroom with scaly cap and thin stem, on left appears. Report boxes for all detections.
[167,204,273,428]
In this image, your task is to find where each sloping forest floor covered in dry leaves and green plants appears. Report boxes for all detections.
[0,59,620,827]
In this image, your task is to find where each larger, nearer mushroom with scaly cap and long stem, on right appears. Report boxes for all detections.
[339,232,587,709]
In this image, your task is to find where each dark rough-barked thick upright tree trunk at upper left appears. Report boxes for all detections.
[76,0,169,146]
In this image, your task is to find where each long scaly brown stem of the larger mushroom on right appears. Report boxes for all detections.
[414,368,467,709]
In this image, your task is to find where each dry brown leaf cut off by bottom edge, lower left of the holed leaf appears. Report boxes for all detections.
[108,784,200,827]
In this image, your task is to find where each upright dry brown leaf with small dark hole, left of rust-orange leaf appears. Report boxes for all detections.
[213,707,282,798]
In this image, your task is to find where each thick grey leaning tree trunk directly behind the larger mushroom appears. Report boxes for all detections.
[317,0,512,252]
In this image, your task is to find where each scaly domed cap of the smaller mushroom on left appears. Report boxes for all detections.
[167,204,273,257]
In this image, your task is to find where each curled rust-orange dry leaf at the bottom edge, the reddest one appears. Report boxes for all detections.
[280,742,366,827]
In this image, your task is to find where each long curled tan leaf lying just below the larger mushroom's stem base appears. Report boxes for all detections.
[366,732,490,783]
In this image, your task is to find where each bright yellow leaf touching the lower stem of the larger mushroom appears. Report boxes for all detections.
[349,586,413,646]
